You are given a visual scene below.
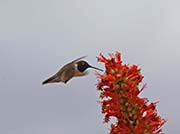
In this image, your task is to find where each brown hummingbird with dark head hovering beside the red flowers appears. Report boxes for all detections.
[42,56,103,85]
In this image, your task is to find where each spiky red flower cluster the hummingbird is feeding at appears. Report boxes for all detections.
[97,52,165,134]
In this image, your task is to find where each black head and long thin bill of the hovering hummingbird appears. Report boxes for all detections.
[76,60,103,72]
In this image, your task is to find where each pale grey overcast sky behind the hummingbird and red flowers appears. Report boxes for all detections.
[0,0,180,134]
